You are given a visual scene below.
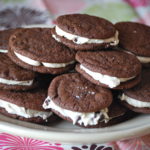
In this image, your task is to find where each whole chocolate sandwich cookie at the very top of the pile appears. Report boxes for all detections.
[52,14,119,50]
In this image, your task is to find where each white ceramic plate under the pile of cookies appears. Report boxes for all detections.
[0,115,150,144]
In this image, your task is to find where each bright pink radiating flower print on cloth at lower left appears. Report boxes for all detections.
[0,133,64,150]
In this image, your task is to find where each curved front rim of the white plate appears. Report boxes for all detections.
[0,115,150,144]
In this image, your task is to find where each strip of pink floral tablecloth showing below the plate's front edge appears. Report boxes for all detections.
[0,133,150,150]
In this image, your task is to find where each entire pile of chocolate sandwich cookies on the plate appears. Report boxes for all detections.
[0,14,150,128]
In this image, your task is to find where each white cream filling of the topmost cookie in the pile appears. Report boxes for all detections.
[54,26,119,45]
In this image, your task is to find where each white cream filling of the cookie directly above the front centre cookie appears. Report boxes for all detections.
[80,65,135,88]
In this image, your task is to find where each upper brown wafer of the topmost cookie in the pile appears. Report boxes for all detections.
[56,14,116,39]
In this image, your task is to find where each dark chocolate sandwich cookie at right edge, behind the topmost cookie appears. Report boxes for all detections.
[115,22,150,67]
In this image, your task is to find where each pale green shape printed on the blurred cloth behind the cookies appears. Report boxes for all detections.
[82,2,138,23]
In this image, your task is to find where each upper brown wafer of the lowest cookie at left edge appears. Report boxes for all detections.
[0,89,47,111]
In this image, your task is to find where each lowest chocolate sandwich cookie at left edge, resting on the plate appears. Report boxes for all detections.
[0,89,53,123]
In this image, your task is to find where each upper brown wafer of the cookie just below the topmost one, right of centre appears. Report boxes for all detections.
[76,51,141,78]
